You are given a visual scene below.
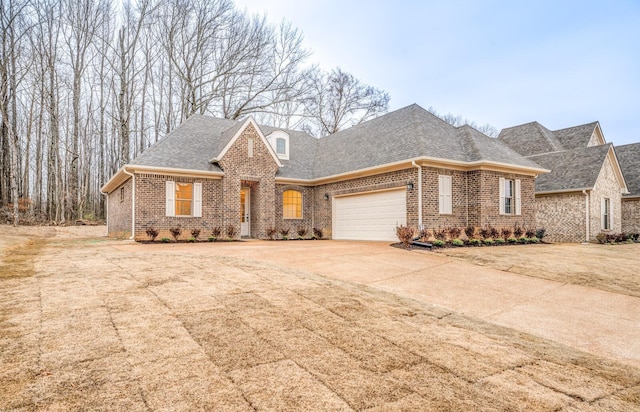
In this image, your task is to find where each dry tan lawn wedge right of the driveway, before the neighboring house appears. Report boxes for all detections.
[438,243,640,297]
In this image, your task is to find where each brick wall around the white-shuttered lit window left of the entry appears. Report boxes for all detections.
[135,173,222,240]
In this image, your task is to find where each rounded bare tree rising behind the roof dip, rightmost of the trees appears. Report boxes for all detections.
[305,68,389,136]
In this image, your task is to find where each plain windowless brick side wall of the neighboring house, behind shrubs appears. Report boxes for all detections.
[536,192,586,242]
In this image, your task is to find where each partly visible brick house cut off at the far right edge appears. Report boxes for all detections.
[616,143,640,233]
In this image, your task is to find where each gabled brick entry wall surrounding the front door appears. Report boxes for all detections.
[219,124,278,238]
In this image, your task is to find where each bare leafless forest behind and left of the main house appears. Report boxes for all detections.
[0,0,389,225]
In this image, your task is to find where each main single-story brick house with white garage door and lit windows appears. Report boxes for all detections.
[102,105,548,240]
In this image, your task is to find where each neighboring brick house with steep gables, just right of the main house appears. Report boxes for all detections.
[498,122,627,242]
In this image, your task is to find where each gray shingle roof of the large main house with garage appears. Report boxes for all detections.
[131,104,540,179]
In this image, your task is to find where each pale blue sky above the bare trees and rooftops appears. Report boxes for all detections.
[234,0,640,145]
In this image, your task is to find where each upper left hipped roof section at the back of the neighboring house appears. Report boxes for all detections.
[498,122,564,156]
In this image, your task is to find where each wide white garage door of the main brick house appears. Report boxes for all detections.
[333,188,407,240]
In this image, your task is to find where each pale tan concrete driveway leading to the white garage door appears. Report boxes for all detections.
[144,241,640,367]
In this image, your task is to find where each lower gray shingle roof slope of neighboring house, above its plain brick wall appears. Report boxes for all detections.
[528,143,612,192]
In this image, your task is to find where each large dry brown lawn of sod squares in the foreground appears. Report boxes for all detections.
[0,226,640,411]
